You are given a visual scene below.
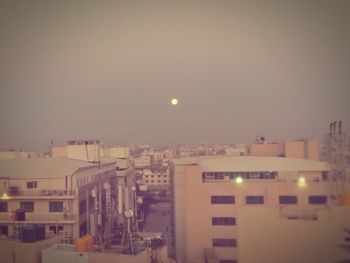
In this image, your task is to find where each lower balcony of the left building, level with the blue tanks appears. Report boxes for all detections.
[0,212,77,224]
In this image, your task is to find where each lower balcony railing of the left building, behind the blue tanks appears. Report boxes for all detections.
[0,212,77,222]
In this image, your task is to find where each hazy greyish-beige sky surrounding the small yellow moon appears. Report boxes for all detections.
[0,0,350,150]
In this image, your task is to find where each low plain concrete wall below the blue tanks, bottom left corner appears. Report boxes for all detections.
[0,237,59,263]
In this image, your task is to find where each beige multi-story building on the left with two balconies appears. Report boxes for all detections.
[0,157,116,239]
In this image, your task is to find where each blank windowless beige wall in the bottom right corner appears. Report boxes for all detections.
[237,207,350,263]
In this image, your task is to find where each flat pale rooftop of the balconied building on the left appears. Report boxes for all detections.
[0,157,115,178]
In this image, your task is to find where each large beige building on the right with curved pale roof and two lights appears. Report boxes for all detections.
[170,156,350,263]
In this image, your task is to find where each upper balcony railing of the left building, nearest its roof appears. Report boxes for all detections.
[0,190,75,197]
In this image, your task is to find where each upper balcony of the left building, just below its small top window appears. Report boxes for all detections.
[0,187,76,199]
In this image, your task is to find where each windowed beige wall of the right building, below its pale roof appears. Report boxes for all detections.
[172,159,338,262]
